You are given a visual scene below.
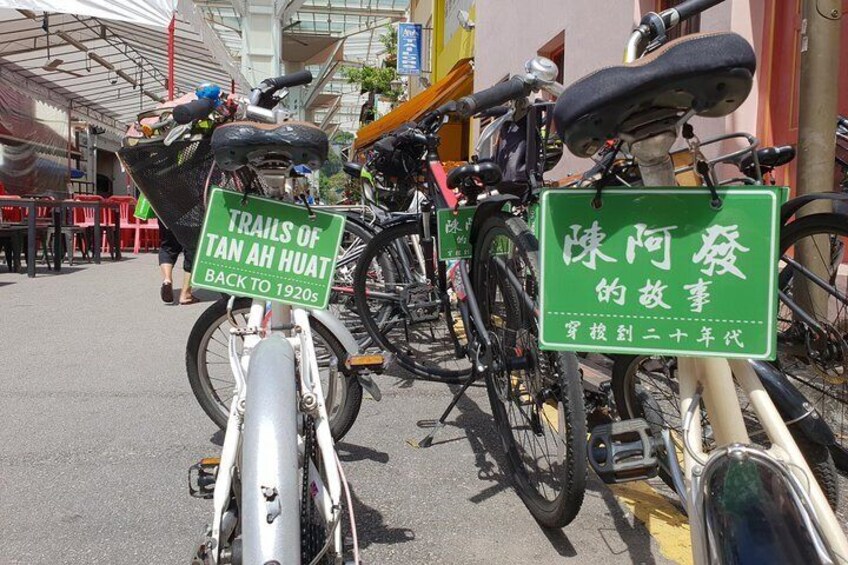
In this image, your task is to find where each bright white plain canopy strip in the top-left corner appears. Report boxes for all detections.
[0,0,176,27]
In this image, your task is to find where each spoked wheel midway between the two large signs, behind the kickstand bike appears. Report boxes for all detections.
[353,222,471,381]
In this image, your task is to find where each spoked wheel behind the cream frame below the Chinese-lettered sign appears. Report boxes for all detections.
[612,355,839,508]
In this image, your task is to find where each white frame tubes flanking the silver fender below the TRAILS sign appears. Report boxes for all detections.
[205,300,343,563]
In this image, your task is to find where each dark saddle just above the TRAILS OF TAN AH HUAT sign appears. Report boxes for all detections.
[212,122,330,171]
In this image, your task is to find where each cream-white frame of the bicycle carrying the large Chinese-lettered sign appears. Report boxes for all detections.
[624,8,848,565]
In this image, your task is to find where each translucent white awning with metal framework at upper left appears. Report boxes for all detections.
[0,0,248,136]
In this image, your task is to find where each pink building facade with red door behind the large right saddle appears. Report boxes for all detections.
[474,0,848,183]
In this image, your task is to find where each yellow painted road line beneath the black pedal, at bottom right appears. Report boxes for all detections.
[609,481,693,565]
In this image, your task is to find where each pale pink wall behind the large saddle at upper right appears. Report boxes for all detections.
[474,0,770,179]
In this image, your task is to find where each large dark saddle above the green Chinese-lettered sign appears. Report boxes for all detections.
[554,33,757,157]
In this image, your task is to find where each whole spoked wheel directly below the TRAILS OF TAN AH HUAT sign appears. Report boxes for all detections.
[186,298,362,440]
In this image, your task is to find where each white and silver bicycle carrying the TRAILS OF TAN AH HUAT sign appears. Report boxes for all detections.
[122,73,383,564]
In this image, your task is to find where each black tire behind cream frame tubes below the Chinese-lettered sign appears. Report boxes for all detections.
[612,355,839,509]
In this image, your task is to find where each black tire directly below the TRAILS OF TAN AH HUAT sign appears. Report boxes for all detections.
[186,298,362,441]
